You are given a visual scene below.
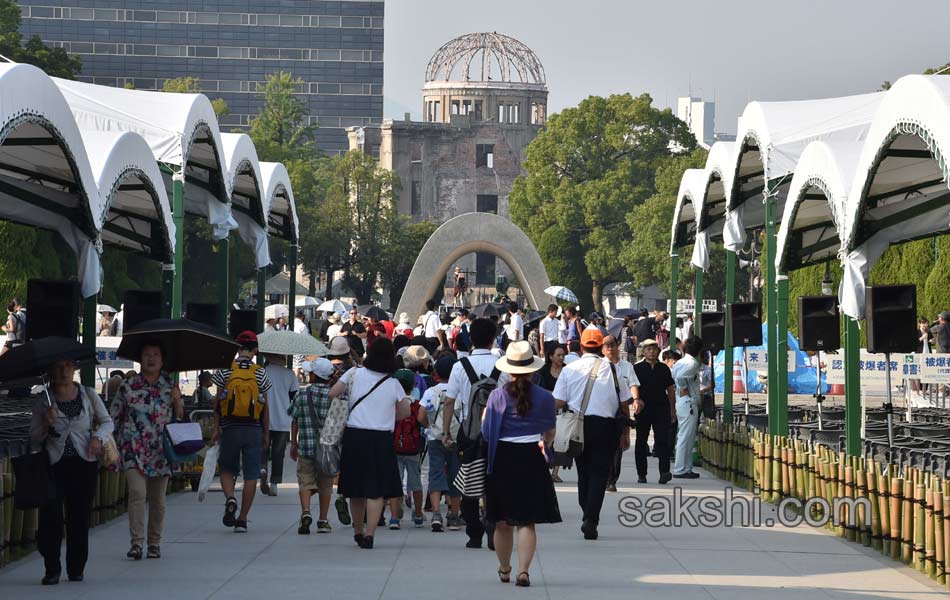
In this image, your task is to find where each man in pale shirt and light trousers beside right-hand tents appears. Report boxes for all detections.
[672,336,703,479]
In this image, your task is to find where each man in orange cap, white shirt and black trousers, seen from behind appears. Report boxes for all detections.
[554,328,633,540]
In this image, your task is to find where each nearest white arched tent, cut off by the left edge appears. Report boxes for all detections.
[0,63,104,298]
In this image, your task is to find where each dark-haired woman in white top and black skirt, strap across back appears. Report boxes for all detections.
[330,337,410,549]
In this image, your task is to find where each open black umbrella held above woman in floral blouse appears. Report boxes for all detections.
[116,319,239,373]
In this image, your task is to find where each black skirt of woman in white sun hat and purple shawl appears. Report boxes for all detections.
[485,442,561,525]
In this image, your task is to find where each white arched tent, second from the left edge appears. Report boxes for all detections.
[80,130,175,264]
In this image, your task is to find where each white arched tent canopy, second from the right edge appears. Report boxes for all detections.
[775,141,861,273]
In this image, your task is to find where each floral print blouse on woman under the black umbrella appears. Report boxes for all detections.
[111,373,174,477]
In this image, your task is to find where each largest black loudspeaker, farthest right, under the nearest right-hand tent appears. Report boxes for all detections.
[866,285,919,354]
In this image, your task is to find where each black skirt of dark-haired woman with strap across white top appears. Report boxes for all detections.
[340,427,402,498]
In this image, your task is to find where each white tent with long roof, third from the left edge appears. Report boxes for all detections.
[53,78,237,239]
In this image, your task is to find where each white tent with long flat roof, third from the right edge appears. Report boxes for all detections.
[723,92,884,250]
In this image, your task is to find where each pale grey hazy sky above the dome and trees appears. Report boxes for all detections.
[384,0,950,133]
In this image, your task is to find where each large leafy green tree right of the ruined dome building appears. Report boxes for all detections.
[509,94,695,307]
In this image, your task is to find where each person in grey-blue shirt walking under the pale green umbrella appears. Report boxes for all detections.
[261,354,299,496]
